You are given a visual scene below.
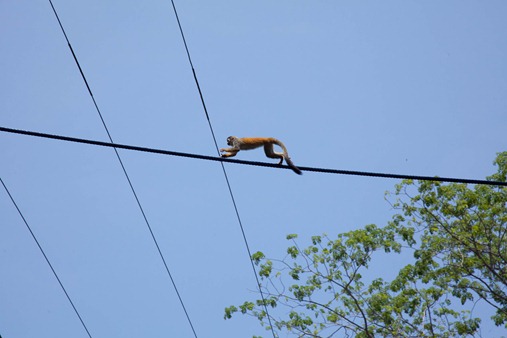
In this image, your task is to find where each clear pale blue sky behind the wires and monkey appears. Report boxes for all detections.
[0,0,507,338]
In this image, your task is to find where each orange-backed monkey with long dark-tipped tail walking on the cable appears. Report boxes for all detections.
[220,136,303,175]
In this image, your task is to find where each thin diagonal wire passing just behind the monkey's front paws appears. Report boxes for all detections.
[171,0,276,338]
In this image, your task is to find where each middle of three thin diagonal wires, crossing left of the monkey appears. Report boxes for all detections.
[49,0,197,338]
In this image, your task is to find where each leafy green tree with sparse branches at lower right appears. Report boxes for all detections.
[225,152,507,337]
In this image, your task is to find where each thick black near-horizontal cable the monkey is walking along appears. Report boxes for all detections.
[0,127,507,186]
